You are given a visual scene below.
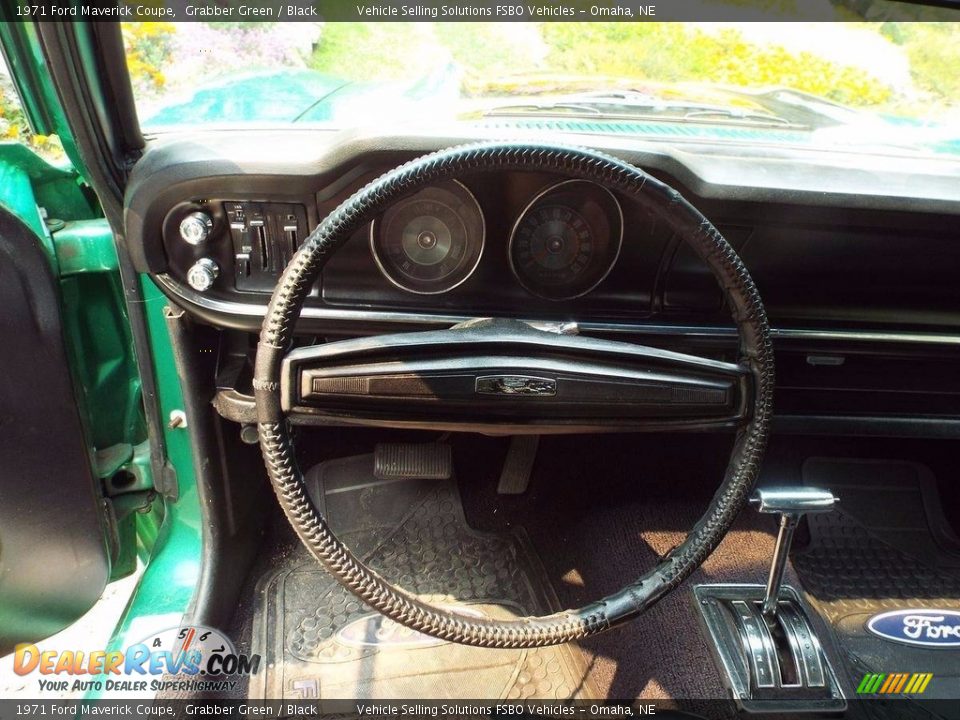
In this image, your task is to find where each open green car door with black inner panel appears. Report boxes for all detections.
[0,24,153,655]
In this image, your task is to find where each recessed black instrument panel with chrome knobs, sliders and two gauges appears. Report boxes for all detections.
[154,167,670,318]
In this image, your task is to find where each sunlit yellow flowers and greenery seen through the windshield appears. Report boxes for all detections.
[124,22,960,131]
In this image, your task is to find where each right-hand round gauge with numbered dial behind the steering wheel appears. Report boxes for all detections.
[510,180,623,300]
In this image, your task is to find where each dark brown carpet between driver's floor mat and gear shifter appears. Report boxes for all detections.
[520,501,773,699]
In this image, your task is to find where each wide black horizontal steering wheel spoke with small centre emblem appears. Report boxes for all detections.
[281,320,751,434]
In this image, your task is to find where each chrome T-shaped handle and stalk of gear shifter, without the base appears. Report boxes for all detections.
[750,487,838,620]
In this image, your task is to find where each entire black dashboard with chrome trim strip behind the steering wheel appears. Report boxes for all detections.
[125,128,960,433]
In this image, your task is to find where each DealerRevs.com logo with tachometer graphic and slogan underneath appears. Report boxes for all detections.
[13,625,260,692]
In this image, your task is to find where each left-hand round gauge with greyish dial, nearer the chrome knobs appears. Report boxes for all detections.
[370,180,484,295]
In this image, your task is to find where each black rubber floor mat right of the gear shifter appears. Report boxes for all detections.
[793,458,960,718]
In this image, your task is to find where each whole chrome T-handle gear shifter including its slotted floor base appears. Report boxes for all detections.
[694,487,846,713]
